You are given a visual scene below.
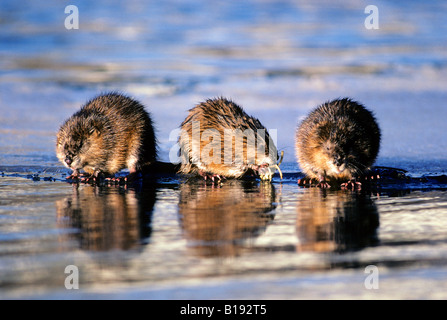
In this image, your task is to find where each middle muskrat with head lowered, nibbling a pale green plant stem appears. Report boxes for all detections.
[179,97,282,181]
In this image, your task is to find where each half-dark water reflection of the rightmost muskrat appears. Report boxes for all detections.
[296,188,379,252]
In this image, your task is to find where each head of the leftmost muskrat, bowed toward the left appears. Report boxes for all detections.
[56,116,108,173]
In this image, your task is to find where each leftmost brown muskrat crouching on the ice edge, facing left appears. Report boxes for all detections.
[56,92,157,179]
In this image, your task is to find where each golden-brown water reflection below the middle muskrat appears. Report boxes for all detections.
[179,180,276,256]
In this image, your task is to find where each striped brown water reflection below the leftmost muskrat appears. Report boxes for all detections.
[56,185,155,251]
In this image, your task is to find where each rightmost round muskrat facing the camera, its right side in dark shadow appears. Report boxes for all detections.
[296,98,381,187]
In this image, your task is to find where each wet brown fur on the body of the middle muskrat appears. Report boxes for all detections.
[179,97,277,178]
